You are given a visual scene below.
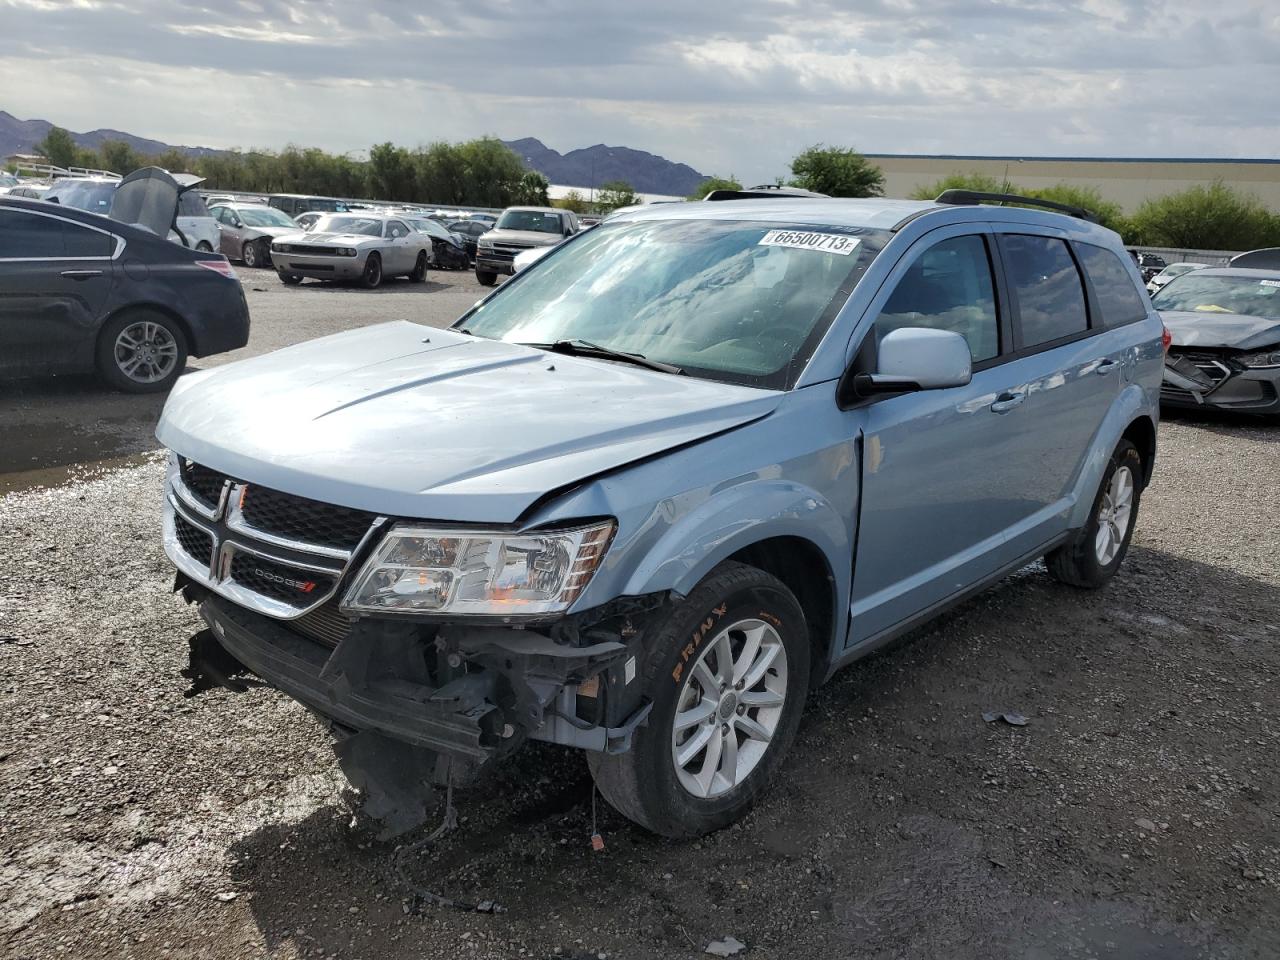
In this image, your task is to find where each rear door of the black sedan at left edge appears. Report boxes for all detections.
[0,206,123,372]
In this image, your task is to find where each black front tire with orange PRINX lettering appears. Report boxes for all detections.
[588,563,809,838]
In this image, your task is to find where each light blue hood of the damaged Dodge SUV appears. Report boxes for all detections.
[156,320,783,524]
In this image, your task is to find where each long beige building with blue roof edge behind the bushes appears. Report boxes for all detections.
[867,154,1280,212]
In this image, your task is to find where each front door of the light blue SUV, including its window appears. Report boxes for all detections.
[850,224,1037,644]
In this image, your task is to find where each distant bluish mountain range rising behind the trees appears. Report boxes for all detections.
[0,110,707,197]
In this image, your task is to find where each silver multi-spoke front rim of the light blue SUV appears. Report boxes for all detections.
[671,620,787,799]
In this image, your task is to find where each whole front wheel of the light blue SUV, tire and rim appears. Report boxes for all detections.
[588,563,809,838]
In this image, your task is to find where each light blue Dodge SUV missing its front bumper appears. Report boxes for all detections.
[157,193,1166,837]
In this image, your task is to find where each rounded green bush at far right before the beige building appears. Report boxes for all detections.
[1132,180,1280,250]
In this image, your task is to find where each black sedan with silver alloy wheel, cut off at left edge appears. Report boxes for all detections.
[0,184,248,393]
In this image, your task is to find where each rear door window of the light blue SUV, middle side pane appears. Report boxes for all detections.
[1001,234,1089,348]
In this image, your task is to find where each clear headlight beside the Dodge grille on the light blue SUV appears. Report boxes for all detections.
[342,520,616,617]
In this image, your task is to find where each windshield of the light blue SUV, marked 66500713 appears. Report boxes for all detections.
[457,220,888,389]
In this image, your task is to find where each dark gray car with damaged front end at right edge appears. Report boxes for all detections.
[1152,268,1280,415]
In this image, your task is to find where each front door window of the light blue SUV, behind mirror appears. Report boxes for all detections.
[876,236,1000,362]
